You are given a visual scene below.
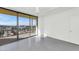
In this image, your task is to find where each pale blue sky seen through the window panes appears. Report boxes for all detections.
[0,14,36,26]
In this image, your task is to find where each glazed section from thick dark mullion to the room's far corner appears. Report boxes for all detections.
[18,14,37,38]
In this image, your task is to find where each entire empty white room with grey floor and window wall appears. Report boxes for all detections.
[0,7,79,51]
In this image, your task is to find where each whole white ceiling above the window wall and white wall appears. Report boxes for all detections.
[4,7,73,16]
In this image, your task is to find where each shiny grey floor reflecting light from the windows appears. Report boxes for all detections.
[0,37,79,51]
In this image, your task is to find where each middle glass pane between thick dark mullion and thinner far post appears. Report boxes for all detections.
[19,14,30,38]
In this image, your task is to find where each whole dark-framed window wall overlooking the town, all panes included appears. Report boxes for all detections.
[0,8,37,43]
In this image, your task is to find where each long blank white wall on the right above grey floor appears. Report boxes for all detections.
[43,8,79,44]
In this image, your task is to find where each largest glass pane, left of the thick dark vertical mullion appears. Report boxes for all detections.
[0,9,17,44]
